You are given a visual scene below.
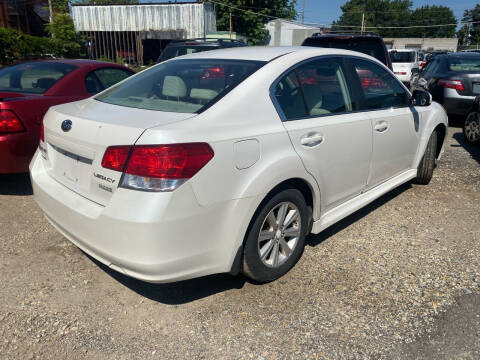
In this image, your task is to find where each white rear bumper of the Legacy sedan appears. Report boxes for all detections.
[30,152,254,282]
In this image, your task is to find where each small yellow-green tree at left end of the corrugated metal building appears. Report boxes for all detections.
[46,14,83,57]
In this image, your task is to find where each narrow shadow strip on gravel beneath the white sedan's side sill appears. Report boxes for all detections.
[306,182,412,246]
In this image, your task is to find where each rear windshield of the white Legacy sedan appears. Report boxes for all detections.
[96,59,265,113]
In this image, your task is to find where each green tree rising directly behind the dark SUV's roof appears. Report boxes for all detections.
[332,0,412,37]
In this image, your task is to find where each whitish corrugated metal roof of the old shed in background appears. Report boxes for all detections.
[72,3,216,39]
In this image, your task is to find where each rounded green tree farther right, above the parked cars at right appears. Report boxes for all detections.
[406,5,457,37]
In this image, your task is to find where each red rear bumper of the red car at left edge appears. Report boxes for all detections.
[0,132,39,174]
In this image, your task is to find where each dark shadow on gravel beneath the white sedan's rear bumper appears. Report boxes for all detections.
[85,254,246,305]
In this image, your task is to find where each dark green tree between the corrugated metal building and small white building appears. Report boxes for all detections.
[215,0,297,45]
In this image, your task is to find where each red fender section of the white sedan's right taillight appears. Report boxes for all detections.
[125,143,213,179]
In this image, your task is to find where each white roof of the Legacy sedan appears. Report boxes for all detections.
[172,46,371,62]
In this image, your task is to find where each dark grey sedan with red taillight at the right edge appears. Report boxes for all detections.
[412,52,480,116]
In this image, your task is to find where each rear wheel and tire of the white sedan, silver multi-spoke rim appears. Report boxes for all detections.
[242,189,312,283]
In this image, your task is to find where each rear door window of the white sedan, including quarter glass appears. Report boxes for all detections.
[274,58,354,120]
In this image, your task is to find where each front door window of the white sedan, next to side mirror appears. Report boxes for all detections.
[352,59,409,110]
